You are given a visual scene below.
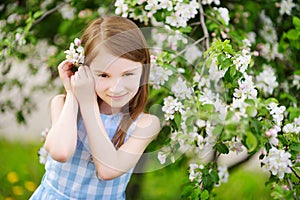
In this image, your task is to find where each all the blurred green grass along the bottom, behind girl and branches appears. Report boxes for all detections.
[0,138,271,200]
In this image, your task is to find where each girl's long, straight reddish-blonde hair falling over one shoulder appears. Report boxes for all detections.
[81,16,150,148]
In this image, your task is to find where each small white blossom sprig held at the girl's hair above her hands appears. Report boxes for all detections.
[64,38,84,67]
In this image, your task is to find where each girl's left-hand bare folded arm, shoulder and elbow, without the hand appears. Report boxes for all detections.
[45,91,78,162]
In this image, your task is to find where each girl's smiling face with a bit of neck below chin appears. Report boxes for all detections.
[90,48,143,114]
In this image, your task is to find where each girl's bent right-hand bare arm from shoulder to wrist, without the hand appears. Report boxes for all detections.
[79,101,160,180]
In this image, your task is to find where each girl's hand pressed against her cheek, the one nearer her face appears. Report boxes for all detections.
[71,66,97,104]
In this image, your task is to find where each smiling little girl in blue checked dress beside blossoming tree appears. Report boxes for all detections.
[30,16,160,200]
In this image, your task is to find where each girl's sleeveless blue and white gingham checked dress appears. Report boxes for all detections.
[30,113,141,200]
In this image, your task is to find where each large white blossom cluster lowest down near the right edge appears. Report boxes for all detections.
[262,147,292,179]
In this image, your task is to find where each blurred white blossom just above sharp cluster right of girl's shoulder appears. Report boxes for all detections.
[171,77,192,99]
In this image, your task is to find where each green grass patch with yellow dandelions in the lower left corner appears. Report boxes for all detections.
[0,139,44,200]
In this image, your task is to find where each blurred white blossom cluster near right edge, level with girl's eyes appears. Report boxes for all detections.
[256,64,279,95]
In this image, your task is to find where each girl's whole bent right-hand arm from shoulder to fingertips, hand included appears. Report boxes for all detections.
[71,66,160,180]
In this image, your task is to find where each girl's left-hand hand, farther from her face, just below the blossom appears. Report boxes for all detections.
[58,60,73,91]
